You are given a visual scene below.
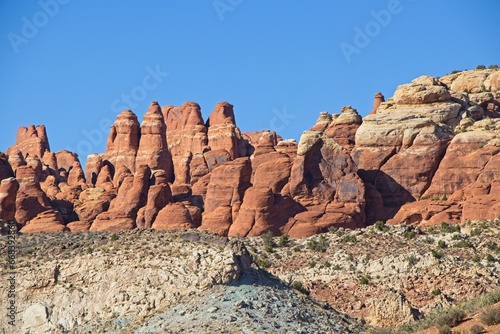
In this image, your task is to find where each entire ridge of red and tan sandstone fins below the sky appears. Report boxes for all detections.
[0,69,500,237]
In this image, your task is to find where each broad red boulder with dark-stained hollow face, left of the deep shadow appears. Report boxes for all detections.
[284,126,365,237]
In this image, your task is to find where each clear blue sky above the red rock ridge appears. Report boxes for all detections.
[0,0,500,163]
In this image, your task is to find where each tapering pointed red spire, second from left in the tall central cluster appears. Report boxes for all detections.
[135,101,174,182]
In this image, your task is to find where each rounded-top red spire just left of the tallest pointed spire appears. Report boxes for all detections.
[103,110,140,172]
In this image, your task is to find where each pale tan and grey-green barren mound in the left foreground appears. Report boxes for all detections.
[0,229,364,333]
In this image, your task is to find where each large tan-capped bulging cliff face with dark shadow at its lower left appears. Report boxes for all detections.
[351,77,460,224]
